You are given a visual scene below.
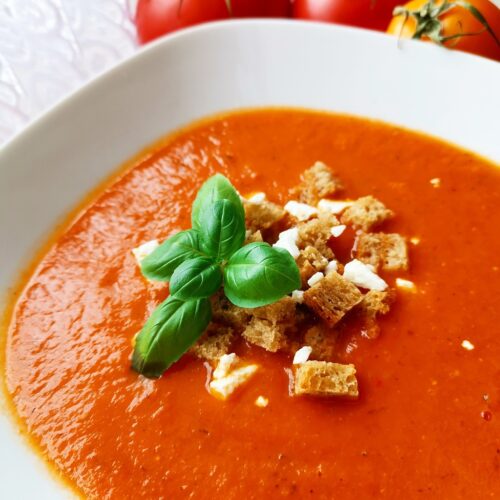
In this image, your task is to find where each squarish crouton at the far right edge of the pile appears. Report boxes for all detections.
[356,233,408,271]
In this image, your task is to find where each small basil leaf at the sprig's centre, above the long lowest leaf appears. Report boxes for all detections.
[170,257,222,300]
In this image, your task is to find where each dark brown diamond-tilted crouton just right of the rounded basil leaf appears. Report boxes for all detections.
[304,272,363,327]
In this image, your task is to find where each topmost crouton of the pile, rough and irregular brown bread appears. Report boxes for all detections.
[291,161,344,206]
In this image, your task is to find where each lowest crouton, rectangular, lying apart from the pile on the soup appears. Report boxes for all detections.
[295,361,359,398]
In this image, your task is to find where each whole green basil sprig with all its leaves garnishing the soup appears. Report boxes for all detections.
[132,174,300,378]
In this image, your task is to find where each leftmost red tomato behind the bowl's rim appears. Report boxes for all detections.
[135,0,291,43]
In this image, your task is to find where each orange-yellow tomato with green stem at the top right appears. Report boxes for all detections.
[387,0,500,61]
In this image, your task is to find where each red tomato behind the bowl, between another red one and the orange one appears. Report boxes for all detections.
[293,0,401,31]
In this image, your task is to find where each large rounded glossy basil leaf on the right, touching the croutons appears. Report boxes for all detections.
[224,242,300,307]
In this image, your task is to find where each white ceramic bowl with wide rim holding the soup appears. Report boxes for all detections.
[0,21,500,500]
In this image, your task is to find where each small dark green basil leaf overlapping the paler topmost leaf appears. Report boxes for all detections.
[200,200,245,262]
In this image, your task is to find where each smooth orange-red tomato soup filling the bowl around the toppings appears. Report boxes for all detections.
[6,110,500,499]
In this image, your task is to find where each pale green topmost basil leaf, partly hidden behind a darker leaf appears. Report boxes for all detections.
[191,174,245,230]
